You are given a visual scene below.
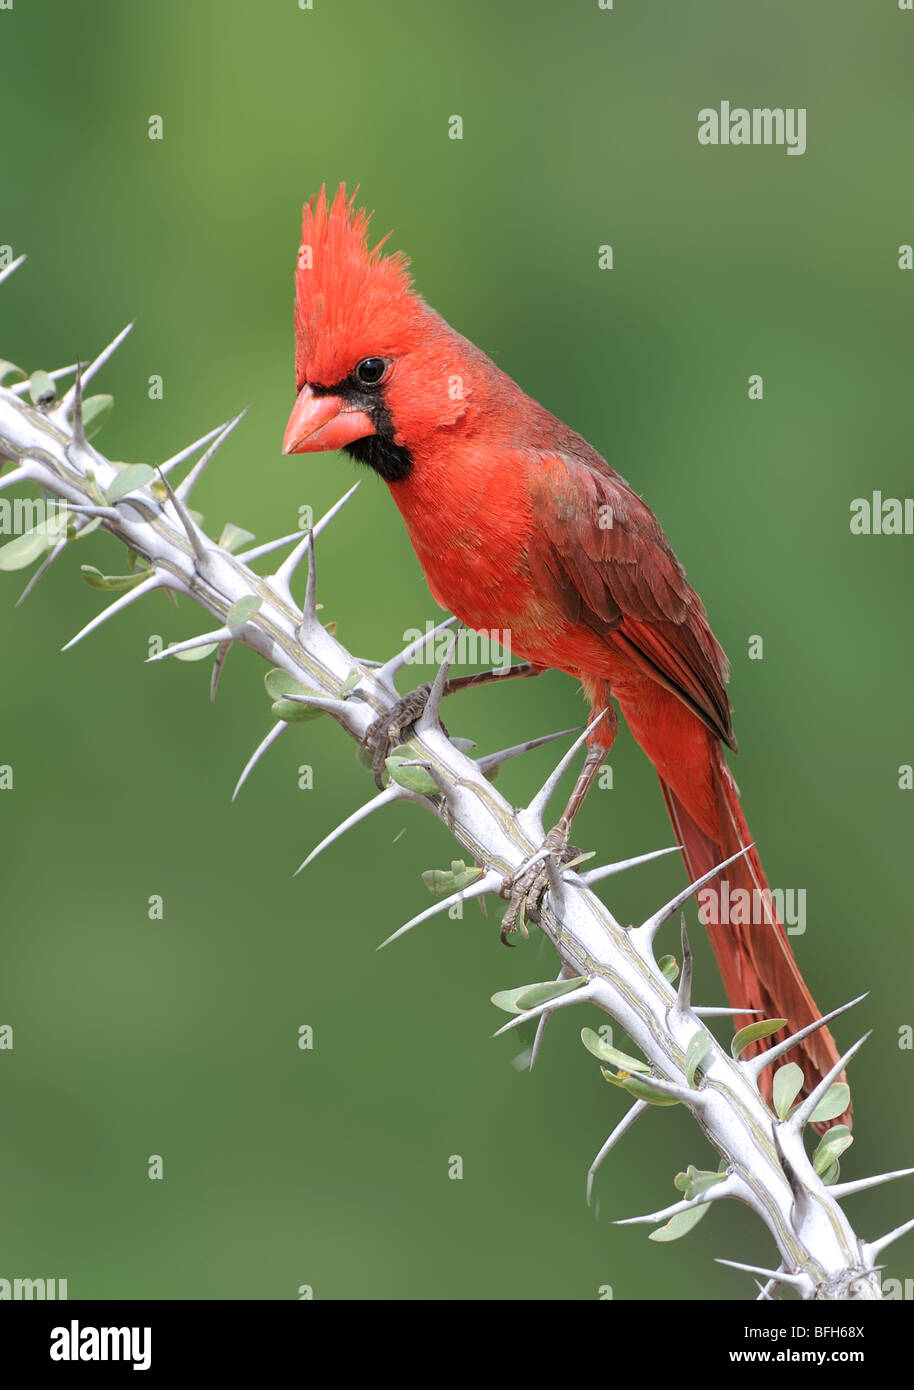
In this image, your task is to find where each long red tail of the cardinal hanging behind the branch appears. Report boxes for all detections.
[660,735,851,1125]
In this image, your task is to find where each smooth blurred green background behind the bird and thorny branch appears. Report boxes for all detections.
[0,0,914,1298]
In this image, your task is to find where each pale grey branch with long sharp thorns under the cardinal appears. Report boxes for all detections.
[0,267,914,1300]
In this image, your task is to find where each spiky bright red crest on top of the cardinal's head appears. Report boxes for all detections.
[294,183,426,386]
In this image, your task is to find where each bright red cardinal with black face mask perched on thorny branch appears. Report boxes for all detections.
[283,186,847,1119]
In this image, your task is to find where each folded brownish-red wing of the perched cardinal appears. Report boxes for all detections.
[528,453,735,748]
